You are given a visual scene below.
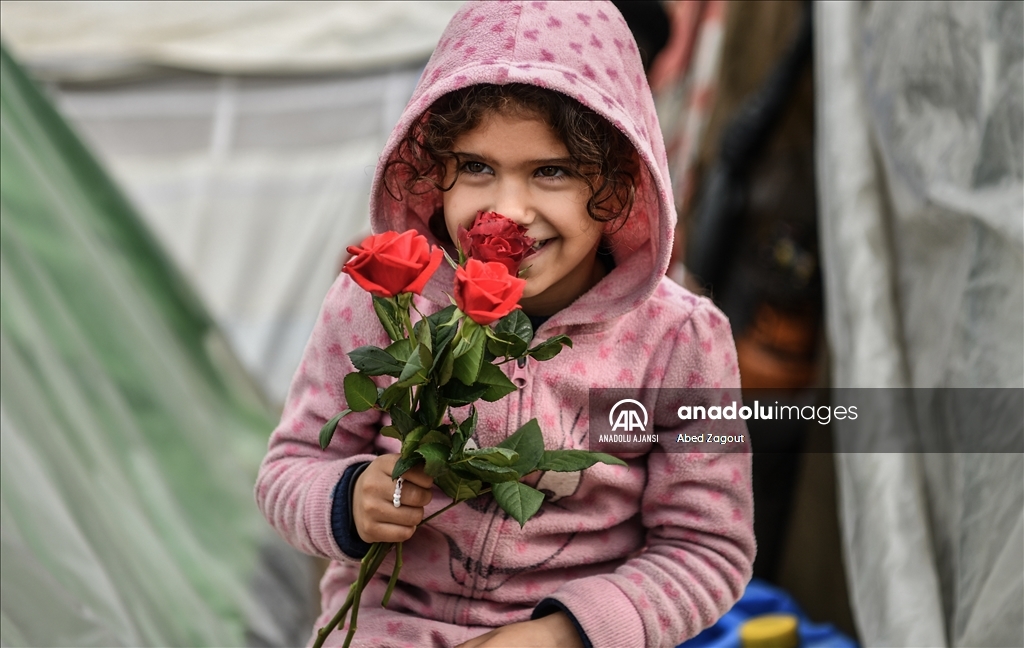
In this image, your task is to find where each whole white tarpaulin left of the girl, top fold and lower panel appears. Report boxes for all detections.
[2,2,461,404]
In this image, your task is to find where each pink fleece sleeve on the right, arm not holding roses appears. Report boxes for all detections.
[551,300,755,648]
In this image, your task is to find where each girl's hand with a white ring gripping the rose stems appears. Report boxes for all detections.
[352,455,434,543]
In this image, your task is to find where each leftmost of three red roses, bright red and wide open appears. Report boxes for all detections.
[341,229,444,297]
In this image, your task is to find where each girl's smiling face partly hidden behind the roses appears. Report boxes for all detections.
[443,113,604,315]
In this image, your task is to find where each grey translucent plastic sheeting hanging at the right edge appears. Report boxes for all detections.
[815,2,1024,646]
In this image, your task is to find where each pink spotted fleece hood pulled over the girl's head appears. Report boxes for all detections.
[370,0,676,327]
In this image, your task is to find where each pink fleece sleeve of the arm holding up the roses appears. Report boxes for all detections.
[256,274,387,561]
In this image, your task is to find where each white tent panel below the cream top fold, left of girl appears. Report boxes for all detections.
[45,64,421,406]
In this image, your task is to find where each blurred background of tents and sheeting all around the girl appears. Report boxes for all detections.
[0,0,1024,646]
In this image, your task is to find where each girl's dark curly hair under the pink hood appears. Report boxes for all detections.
[384,83,640,227]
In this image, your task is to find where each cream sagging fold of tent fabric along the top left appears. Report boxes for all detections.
[0,0,462,81]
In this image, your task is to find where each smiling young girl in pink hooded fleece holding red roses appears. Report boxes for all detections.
[256,2,754,647]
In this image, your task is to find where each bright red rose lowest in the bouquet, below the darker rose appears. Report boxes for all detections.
[455,259,526,326]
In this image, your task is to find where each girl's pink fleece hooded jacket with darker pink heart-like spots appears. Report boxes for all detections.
[256,2,755,648]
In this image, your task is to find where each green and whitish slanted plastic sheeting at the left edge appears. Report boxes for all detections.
[0,45,313,646]
